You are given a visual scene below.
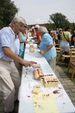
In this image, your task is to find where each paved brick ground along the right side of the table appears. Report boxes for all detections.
[56,65,75,106]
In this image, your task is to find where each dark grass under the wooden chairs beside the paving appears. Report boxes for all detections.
[58,57,75,83]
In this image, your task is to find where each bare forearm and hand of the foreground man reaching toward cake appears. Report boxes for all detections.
[3,47,36,66]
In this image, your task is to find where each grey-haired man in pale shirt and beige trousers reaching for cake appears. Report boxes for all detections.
[0,17,36,113]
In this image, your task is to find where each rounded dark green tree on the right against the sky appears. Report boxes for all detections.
[49,13,70,28]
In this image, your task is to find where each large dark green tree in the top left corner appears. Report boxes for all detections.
[0,0,18,28]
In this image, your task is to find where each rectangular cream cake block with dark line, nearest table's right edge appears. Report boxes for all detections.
[42,75,59,87]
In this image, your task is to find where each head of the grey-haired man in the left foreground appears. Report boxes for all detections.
[10,17,27,33]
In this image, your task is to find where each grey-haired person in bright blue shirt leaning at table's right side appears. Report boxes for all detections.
[39,26,56,72]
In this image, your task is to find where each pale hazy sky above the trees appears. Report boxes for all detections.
[12,0,75,24]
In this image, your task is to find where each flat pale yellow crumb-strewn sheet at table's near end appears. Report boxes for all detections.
[33,92,59,113]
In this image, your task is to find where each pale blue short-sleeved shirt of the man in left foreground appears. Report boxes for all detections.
[0,27,16,61]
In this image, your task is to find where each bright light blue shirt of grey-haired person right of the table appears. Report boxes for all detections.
[40,33,56,61]
